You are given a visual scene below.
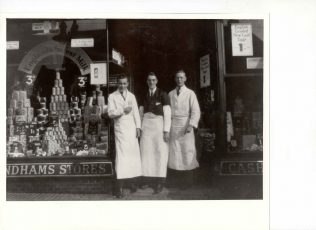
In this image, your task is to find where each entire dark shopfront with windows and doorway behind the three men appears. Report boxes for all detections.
[7,19,263,193]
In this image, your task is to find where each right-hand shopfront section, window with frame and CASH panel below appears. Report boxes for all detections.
[217,20,263,175]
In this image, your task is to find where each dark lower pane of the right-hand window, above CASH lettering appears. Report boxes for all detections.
[226,78,263,153]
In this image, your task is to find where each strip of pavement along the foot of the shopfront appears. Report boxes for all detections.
[7,167,263,201]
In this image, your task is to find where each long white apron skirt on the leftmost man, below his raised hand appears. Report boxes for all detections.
[114,113,142,179]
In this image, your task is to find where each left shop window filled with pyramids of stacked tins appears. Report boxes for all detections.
[7,19,109,158]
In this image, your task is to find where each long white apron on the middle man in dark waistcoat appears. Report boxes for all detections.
[140,113,169,177]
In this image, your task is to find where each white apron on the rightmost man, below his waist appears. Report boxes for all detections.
[168,116,199,170]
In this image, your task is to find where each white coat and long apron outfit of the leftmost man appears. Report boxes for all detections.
[108,92,141,179]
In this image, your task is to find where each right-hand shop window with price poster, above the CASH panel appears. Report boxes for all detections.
[223,20,263,154]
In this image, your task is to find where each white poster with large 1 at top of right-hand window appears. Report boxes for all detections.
[231,23,253,56]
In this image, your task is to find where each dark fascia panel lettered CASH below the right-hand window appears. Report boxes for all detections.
[220,161,263,175]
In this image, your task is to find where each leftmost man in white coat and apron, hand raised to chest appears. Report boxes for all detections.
[108,77,142,198]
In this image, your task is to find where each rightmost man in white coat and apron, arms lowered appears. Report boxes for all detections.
[168,70,201,187]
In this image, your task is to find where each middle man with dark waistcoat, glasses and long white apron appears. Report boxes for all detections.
[139,72,171,193]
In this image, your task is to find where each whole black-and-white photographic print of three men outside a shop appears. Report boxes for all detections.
[6,17,268,201]
